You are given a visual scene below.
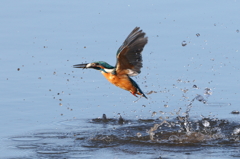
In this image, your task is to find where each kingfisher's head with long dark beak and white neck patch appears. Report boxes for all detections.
[73,61,115,73]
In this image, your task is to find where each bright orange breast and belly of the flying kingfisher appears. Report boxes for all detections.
[102,72,137,93]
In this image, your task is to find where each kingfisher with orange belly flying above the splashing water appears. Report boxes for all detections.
[73,27,148,99]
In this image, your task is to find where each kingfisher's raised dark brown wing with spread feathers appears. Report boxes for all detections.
[116,27,148,76]
